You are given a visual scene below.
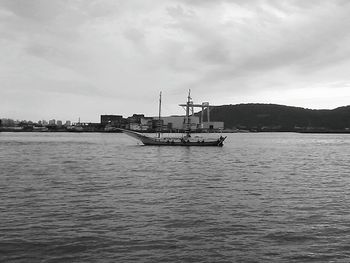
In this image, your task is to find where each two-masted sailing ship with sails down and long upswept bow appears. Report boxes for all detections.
[121,90,226,146]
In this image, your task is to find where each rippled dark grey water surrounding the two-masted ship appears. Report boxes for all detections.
[0,133,350,262]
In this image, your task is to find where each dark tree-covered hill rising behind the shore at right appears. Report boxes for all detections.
[204,104,350,131]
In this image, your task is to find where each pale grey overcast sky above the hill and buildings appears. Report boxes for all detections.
[0,0,350,122]
